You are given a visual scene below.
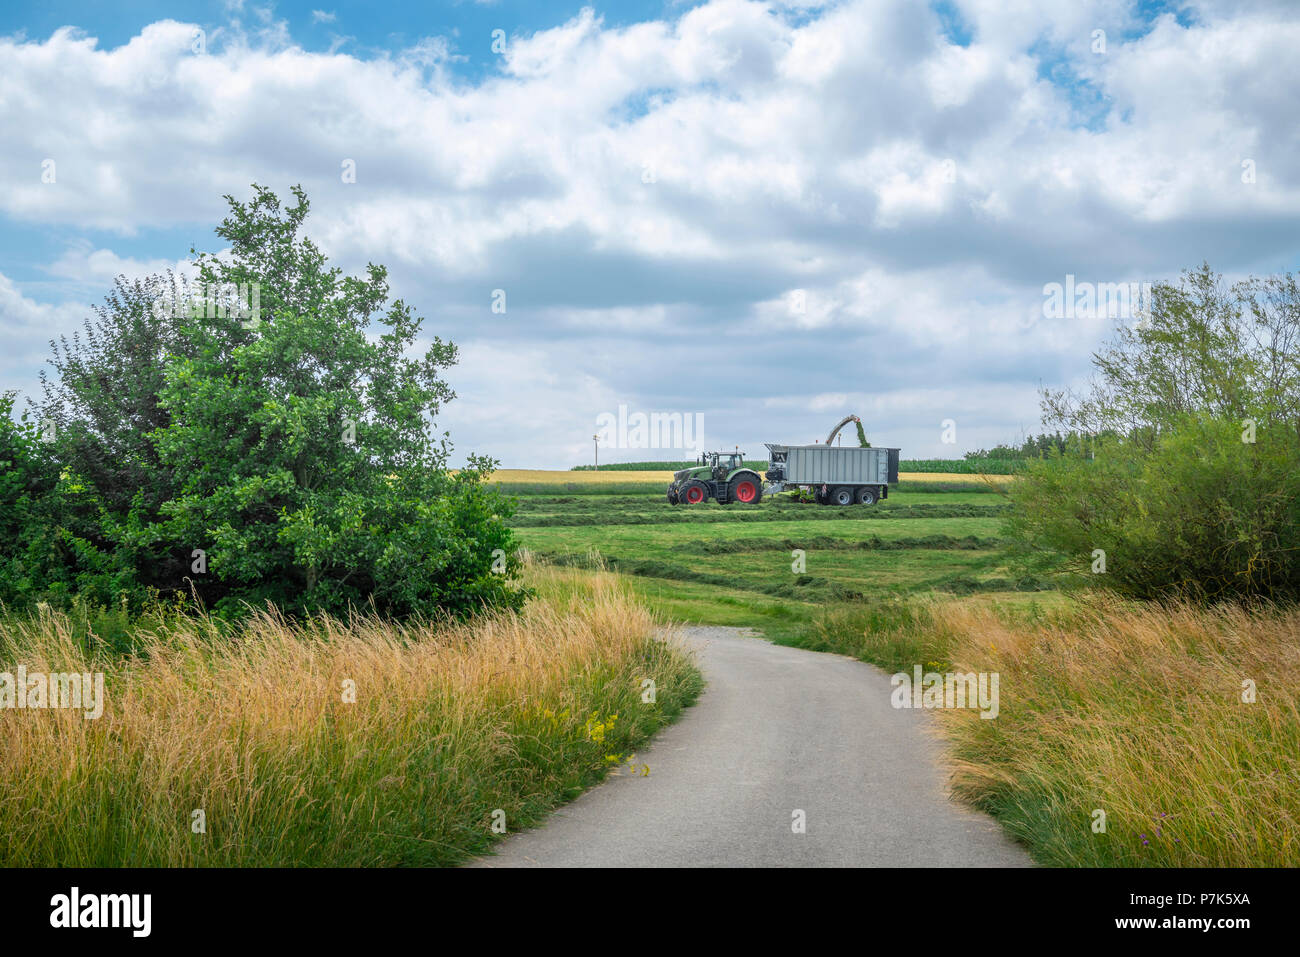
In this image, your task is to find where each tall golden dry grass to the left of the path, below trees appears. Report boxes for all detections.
[0,570,701,866]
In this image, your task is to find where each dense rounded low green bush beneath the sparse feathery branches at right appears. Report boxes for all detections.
[1009,420,1300,599]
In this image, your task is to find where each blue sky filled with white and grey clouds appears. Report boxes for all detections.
[0,0,1300,468]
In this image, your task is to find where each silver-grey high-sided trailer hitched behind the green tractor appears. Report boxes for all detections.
[764,442,898,505]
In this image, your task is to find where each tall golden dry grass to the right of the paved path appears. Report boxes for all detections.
[800,598,1300,867]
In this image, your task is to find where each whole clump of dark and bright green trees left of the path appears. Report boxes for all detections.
[0,186,524,615]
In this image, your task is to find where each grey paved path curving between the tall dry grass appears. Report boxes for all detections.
[475,625,1030,867]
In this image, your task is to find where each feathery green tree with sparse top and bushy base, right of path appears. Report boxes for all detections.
[1009,265,1300,601]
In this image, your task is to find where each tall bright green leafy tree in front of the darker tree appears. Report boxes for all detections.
[133,186,523,615]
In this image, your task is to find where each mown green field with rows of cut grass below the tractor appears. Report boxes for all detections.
[501,481,1044,640]
